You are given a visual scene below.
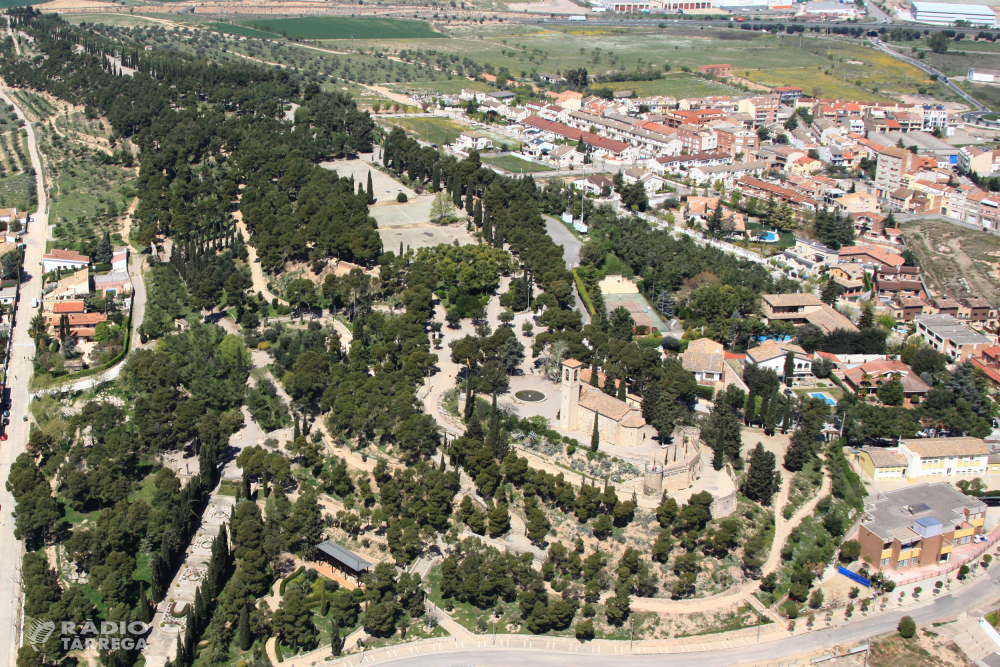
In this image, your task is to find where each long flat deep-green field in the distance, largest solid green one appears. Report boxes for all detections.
[240,16,448,39]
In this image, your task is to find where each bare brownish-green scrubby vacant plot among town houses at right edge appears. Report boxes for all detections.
[899,218,1000,303]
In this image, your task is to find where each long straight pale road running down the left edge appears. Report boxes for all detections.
[0,86,48,665]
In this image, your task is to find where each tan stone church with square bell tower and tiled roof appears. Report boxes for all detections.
[559,359,646,447]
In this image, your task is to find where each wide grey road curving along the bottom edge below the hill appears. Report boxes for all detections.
[366,568,1000,667]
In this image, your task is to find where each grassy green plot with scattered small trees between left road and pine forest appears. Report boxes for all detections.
[38,108,136,250]
